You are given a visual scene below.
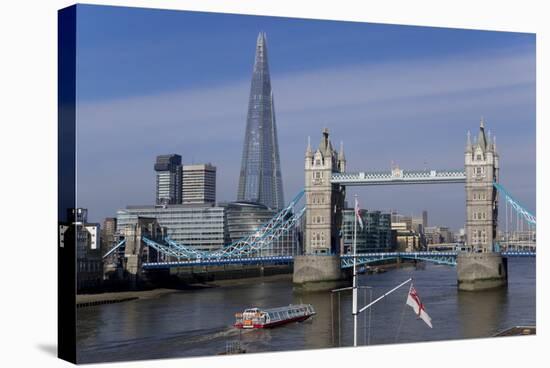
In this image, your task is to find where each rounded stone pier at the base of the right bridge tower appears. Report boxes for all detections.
[456,252,508,291]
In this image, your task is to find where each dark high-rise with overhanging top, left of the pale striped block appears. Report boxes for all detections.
[155,154,182,205]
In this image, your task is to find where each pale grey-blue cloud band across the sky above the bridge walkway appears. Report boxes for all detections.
[77,44,535,224]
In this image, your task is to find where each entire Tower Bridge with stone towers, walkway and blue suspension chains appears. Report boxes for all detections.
[105,121,536,290]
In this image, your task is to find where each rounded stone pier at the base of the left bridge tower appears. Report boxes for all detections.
[292,255,348,291]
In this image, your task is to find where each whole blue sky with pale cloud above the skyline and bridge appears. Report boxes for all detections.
[77,5,535,229]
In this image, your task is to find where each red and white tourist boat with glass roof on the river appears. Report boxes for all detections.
[234,304,315,329]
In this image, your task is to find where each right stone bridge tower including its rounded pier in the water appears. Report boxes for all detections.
[457,119,508,291]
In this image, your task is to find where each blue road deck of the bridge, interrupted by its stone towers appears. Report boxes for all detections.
[142,251,536,270]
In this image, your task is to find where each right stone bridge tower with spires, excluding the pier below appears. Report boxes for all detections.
[464,120,499,252]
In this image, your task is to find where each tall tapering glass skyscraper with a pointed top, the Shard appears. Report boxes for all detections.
[237,32,284,209]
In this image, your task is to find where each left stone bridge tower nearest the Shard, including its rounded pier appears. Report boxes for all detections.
[293,128,346,289]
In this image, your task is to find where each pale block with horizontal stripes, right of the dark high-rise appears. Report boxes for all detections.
[181,164,216,204]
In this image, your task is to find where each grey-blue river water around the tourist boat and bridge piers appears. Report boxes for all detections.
[77,258,536,363]
